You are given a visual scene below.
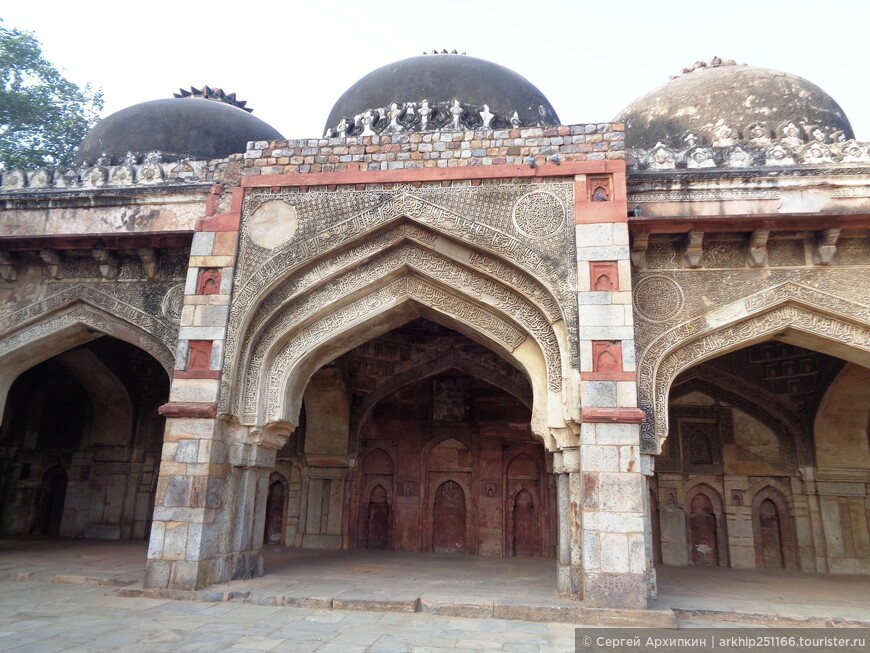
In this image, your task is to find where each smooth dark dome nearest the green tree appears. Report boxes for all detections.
[75,97,283,165]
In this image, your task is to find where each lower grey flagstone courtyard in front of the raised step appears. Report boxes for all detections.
[0,580,574,653]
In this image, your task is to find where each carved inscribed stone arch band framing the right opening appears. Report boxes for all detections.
[638,296,870,454]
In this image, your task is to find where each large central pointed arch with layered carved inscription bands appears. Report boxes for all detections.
[220,198,576,448]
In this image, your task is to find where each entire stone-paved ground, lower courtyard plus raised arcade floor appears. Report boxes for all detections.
[0,539,870,653]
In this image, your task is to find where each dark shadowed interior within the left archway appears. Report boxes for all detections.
[0,337,169,539]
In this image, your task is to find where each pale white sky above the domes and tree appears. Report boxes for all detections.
[0,0,870,141]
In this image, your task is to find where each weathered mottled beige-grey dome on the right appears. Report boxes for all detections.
[615,62,854,148]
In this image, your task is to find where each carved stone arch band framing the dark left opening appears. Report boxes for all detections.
[0,302,174,420]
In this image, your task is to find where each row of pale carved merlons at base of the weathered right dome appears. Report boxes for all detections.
[629,130,870,171]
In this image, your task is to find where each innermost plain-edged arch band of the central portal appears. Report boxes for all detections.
[261,299,567,451]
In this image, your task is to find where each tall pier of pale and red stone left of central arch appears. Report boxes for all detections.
[145,186,243,590]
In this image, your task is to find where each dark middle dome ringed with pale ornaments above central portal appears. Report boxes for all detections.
[326,54,559,131]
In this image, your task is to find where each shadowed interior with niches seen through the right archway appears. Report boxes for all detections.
[651,340,870,573]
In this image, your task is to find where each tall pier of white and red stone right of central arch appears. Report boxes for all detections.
[569,161,655,608]
